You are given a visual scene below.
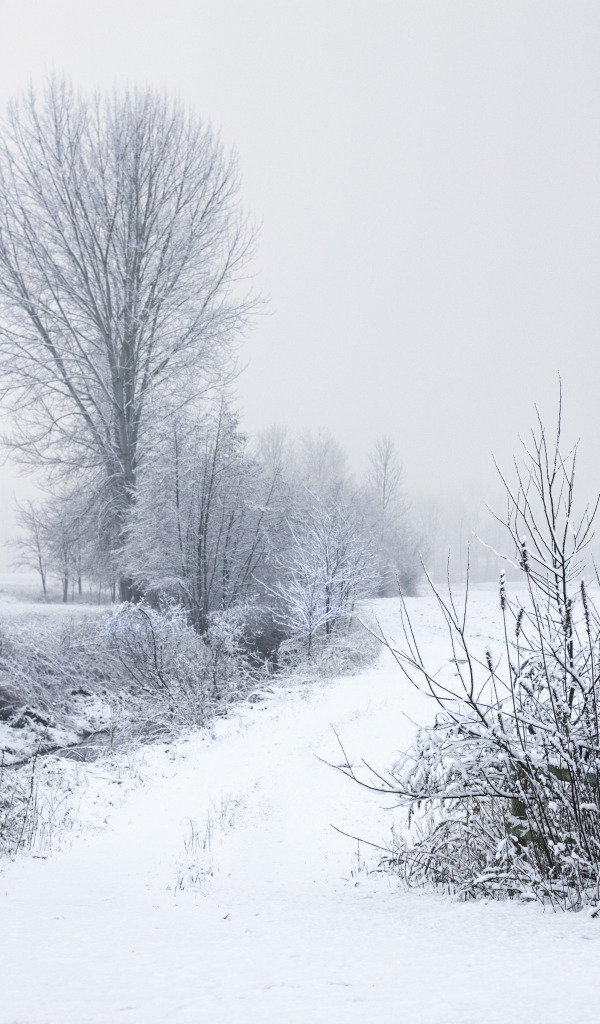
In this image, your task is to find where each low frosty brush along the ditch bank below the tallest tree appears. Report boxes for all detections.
[0,601,253,764]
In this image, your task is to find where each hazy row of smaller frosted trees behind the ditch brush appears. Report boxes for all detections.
[11,413,420,656]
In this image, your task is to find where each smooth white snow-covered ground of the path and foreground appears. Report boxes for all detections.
[0,592,600,1024]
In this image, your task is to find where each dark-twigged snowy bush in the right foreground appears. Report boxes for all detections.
[358,403,600,908]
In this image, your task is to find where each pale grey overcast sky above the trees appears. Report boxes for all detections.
[0,0,600,544]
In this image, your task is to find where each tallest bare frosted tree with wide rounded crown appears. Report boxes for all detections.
[0,81,252,599]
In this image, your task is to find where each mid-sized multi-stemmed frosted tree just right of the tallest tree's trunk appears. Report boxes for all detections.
[127,402,276,633]
